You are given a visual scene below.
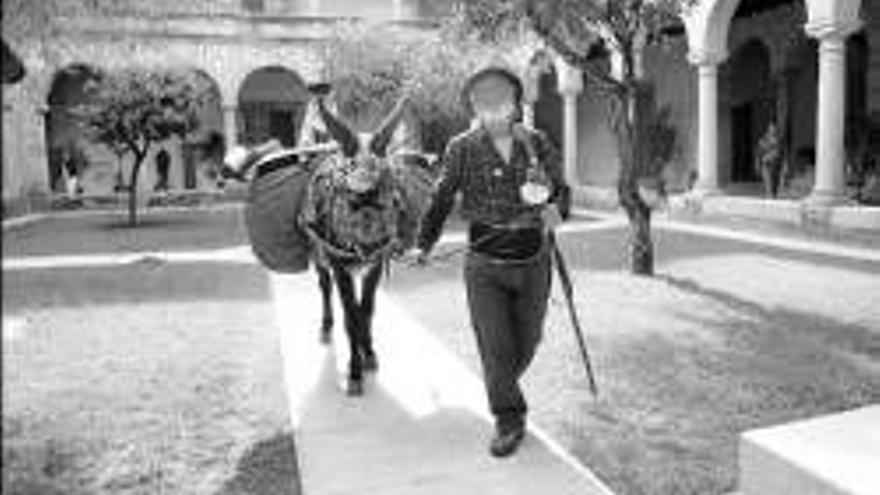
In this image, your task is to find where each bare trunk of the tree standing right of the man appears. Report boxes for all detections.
[615,84,654,276]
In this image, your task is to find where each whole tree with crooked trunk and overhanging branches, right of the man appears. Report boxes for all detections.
[458,0,697,275]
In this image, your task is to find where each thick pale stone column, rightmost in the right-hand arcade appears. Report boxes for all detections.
[807,26,849,205]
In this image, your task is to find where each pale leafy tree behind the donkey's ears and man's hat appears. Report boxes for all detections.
[323,22,524,153]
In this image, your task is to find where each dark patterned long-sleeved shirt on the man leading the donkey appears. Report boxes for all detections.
[418,127,569,250]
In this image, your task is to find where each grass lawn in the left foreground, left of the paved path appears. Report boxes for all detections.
[3,262,298,495]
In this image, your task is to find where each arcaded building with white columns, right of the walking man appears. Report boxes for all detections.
[529,0,880,211]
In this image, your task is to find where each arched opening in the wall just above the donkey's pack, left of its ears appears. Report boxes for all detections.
[237,65,309,146]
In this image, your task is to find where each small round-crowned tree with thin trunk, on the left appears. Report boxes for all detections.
[77,69,210,225]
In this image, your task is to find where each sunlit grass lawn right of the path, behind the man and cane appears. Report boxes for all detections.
[391,232,880,495]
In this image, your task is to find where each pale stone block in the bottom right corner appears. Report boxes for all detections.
[739,405,880,495]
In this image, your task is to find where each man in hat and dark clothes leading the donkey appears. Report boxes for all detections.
[418,67,569,457]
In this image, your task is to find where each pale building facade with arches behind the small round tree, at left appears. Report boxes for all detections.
[3,0,451,210]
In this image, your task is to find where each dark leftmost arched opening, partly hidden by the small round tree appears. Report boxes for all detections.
[44,63,100,192]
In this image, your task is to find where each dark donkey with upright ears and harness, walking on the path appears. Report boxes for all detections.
[229,98,430,396]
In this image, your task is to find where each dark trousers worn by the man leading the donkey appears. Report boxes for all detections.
[465,247,551,431]
